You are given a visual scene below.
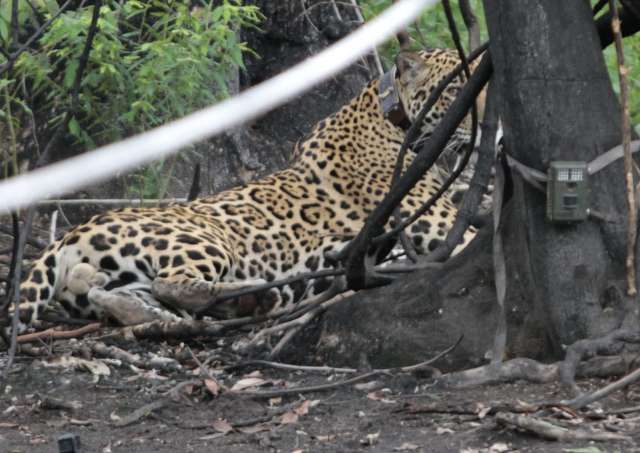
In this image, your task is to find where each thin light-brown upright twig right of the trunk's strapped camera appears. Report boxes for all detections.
[609,0,638,296]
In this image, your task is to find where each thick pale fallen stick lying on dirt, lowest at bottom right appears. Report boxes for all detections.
[496,412,631,442]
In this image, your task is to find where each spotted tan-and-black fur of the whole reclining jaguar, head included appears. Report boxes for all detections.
[13,50,475,323]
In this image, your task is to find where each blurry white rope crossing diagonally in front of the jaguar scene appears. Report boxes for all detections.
[0,0,439,212]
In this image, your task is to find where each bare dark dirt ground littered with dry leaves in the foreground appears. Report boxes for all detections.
[0,332,640,453]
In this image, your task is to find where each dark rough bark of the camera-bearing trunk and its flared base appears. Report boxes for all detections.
[300,0,636,368]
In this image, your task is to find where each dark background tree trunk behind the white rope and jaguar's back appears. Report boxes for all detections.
[186,0,370,198]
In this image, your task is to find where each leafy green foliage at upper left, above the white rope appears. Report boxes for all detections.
[0,0,262,194]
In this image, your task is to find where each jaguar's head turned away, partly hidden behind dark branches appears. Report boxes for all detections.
[396,49,484,162]
